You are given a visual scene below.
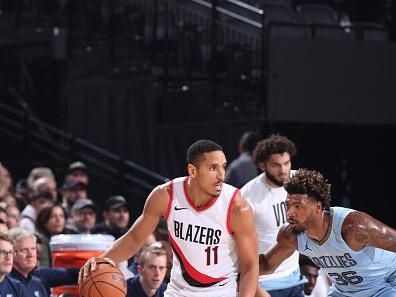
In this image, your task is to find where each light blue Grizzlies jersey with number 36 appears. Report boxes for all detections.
[297,207,396,297]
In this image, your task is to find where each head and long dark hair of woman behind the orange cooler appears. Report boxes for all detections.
[36,204,67,266]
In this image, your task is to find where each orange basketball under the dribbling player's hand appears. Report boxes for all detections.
[79,262,127,297]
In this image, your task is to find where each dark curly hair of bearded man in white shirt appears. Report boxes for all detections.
[253,134,297,165]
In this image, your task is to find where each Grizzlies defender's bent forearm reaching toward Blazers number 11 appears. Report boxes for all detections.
[259,224,297,275]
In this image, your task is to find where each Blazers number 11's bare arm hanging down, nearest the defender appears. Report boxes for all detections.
[230,193,258,297]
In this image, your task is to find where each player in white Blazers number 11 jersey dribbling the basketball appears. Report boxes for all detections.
[80,140,258,297]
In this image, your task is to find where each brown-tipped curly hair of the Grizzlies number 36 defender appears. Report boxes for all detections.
[284,168,331,210]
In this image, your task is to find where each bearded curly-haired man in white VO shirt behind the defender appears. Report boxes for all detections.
[241,135,306,297]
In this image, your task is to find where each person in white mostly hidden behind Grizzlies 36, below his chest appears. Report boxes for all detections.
[299,254,329,297]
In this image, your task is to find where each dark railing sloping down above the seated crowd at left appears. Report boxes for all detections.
[0,103,168,198]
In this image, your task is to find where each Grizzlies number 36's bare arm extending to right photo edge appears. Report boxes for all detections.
[342,211,396,252]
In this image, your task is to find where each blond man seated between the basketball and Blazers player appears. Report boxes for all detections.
[127,242,168,297]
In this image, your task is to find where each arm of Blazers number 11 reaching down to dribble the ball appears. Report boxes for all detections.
[79,184,169,282]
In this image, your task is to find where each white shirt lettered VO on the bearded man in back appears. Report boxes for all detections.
[241,173,299,281]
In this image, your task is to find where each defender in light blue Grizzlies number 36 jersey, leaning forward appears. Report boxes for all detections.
[259,169,396,297]
